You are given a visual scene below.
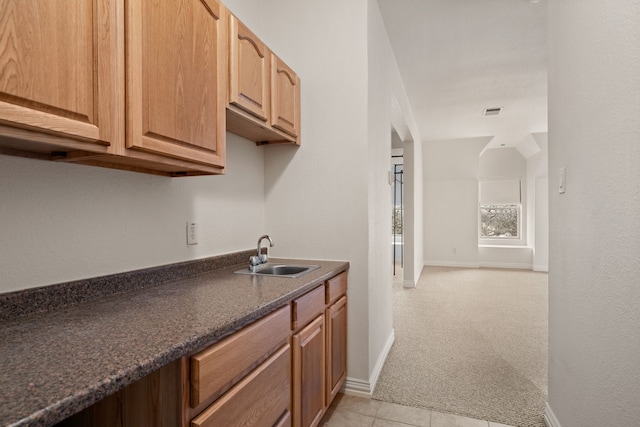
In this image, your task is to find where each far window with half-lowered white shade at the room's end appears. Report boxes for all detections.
[479,178,522,239]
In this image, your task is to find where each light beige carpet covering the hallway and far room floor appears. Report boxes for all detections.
[373,267,548,427]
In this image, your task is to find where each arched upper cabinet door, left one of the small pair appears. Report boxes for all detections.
[229,15,271,122]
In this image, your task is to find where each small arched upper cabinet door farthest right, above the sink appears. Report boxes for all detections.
[271,54,300,137]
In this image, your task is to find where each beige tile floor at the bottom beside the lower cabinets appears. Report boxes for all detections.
[320,393,512,427]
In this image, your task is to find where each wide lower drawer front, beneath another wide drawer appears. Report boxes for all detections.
[191,344,291,427]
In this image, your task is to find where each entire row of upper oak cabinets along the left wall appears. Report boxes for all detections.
[0,0,300,176]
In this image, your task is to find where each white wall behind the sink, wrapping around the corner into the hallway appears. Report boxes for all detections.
[259,0,404,392]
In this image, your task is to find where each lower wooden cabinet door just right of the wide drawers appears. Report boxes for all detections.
[293,315,325,427]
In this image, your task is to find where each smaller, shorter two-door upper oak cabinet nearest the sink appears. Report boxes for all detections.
[227,15,300,144]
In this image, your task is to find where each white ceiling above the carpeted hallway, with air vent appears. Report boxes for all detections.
[378,0,547,148]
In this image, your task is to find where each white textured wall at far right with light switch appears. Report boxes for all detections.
[547,0,640,427]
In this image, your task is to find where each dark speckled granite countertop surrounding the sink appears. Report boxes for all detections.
[0,254,349,426]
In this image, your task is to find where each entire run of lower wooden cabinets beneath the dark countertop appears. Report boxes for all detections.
[53,272,347,427]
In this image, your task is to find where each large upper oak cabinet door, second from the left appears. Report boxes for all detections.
[126,0,226,167]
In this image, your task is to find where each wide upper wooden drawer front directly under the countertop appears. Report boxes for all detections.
[190,306,291,408]
